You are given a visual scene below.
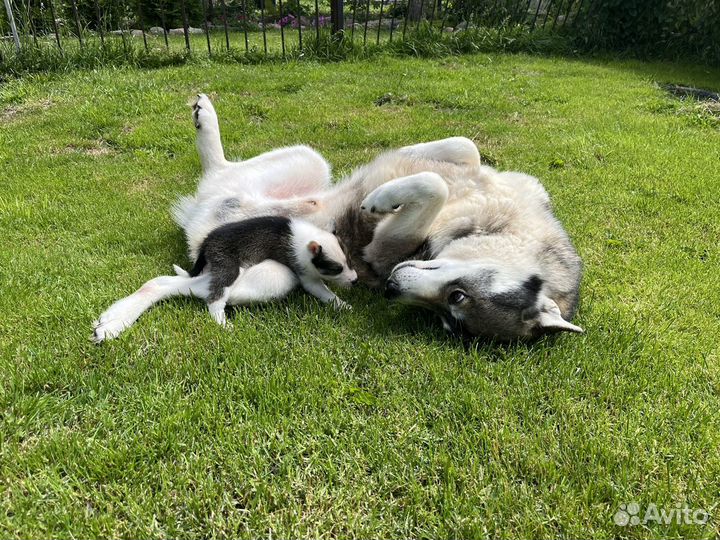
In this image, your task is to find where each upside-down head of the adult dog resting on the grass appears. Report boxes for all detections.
[385,259,583,340]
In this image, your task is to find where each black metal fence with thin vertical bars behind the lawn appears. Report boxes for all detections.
[0,0,593,55]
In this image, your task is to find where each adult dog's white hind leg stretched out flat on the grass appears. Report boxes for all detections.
[92,275,209,343]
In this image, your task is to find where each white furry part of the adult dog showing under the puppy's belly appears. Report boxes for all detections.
[226,260,298,305]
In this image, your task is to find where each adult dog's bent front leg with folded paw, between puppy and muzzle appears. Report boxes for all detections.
[361,172,449,276]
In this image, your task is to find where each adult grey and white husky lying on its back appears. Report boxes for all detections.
[93,95,582,342]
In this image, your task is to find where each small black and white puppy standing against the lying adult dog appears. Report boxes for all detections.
[175,216,357,325]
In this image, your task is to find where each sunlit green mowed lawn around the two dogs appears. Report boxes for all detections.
[0,55,720,539]
